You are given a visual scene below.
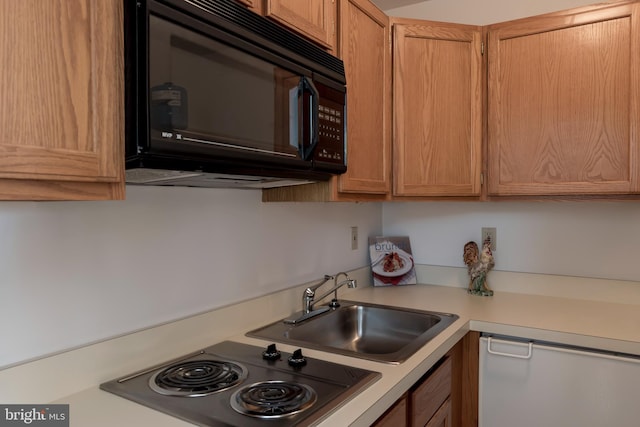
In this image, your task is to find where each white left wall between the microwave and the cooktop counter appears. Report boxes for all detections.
[0,186,382,367]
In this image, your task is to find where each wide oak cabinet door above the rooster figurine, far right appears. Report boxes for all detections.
[488,2,640,195]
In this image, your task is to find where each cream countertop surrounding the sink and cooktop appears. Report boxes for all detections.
[50,285,640,427]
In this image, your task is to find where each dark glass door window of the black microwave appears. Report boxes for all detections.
[149,16,318,164]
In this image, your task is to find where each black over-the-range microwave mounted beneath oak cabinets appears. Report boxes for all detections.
[124,0,347,188]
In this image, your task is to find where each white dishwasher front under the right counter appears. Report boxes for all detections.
[478,336,640,427]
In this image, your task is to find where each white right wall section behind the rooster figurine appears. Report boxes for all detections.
[383,201,640,282]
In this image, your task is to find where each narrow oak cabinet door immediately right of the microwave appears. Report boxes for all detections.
[338,0,391,195]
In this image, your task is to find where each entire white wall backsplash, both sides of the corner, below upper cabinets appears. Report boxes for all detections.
[5,186,640,367]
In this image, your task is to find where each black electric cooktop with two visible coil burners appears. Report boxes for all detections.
[100,341,380,427]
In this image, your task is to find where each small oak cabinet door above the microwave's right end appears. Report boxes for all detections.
[265,0,336,49]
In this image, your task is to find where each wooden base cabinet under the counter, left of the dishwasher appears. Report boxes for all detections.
[373,332,479,427]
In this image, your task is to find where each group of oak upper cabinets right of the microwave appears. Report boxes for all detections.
[263,0,640,201]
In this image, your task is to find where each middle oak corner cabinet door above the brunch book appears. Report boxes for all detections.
[393,19,482,196]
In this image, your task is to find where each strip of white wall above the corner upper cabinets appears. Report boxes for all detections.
[373,0,606,25]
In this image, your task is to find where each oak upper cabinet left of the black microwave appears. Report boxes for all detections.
[0,0,125,200]
